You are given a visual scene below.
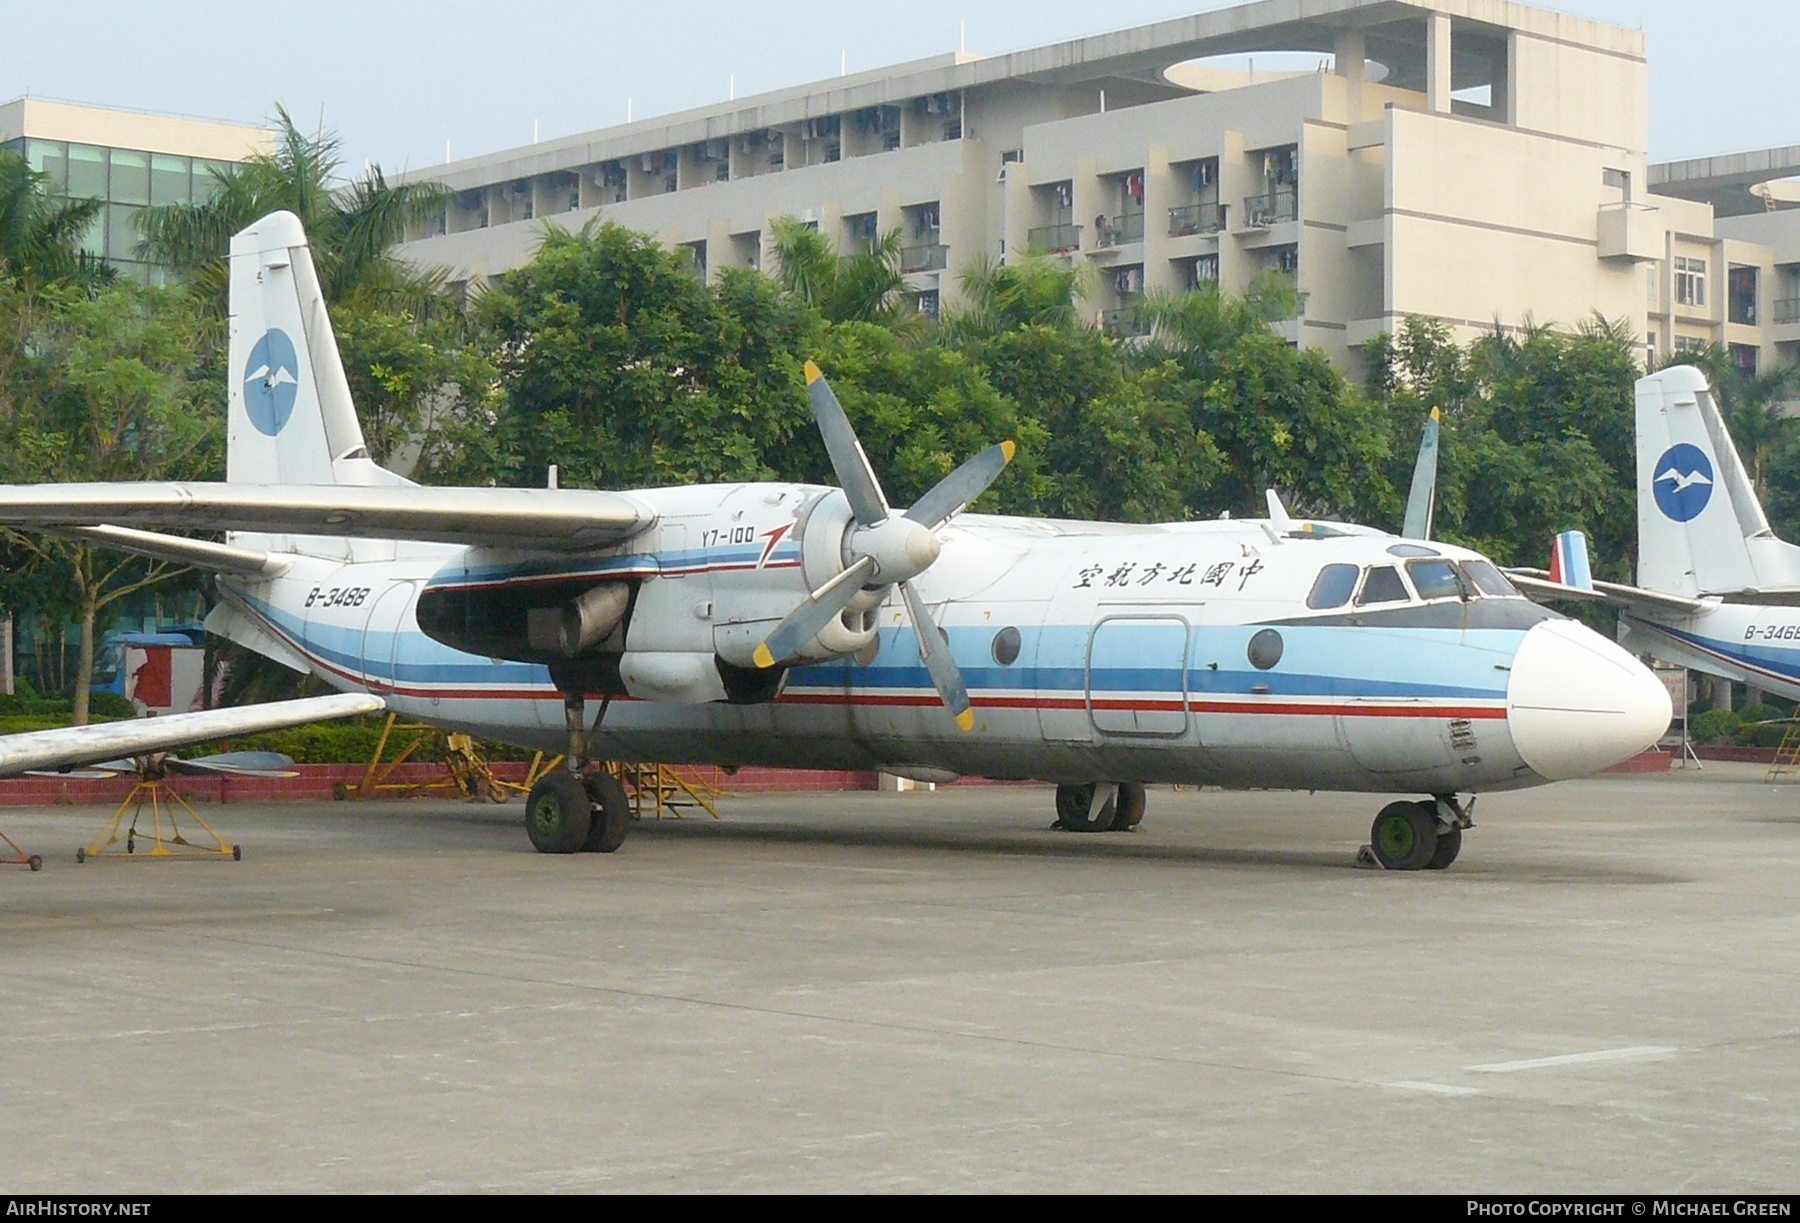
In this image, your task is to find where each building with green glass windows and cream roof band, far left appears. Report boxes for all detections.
[0,97,274,279]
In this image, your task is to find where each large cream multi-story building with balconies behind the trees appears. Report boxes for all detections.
[403,0,1665,369]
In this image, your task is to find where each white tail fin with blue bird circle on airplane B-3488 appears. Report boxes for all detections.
[225,213,405,485]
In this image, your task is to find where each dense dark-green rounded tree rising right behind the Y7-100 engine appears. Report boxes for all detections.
[477,222,819,488]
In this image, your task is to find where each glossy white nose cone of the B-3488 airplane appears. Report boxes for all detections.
[1507,620,1672,782]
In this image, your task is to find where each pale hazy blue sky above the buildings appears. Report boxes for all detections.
[0,0,1800,173]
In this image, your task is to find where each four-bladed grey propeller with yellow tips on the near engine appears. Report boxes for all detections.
[756,360,1015,729]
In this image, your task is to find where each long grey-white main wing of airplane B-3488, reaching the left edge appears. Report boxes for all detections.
[0,485,657,551]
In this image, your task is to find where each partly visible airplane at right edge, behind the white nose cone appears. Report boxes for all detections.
[1510,366,1800,701]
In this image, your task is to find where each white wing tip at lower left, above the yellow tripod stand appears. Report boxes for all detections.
[0,692,387,776]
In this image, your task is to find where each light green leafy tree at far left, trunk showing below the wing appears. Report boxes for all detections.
[0,283,225,724]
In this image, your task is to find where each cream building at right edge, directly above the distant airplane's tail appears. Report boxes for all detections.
[1645,146,1800,373]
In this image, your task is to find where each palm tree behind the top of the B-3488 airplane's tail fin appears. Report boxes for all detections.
[137,103,450,317]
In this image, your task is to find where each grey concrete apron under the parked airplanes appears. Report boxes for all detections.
[0,766,1800,1192]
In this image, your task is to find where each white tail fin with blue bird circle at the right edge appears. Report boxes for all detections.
[1638,366,1800,598]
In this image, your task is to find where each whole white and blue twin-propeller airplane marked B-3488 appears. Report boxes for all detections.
[0,213,1670,870]
